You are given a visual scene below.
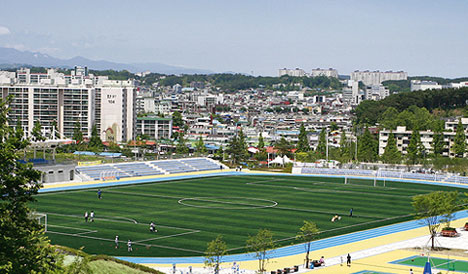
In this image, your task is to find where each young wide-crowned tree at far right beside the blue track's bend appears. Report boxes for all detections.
[412,191,458,249]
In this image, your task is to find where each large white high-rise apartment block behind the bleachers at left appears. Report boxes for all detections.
[0,67,136,142]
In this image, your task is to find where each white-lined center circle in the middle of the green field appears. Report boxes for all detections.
[177,197,278,209]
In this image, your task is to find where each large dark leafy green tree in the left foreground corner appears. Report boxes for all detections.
[0,97,59,273]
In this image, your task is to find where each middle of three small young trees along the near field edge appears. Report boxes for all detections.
[247,229,275,273]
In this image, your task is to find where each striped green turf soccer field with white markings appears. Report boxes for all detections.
[32,176,466,257]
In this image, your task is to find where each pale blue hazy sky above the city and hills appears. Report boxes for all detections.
[0,0,468,78]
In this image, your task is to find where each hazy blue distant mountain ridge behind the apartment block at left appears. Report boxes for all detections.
[0,47,213,74]
